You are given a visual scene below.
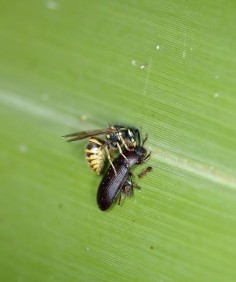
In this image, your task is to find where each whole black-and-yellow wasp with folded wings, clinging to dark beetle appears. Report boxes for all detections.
[63,125,141,174]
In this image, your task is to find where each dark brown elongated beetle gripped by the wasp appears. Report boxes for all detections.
[97,140,151,211]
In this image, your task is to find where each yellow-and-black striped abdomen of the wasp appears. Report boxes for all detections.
[85,137,105,174]
